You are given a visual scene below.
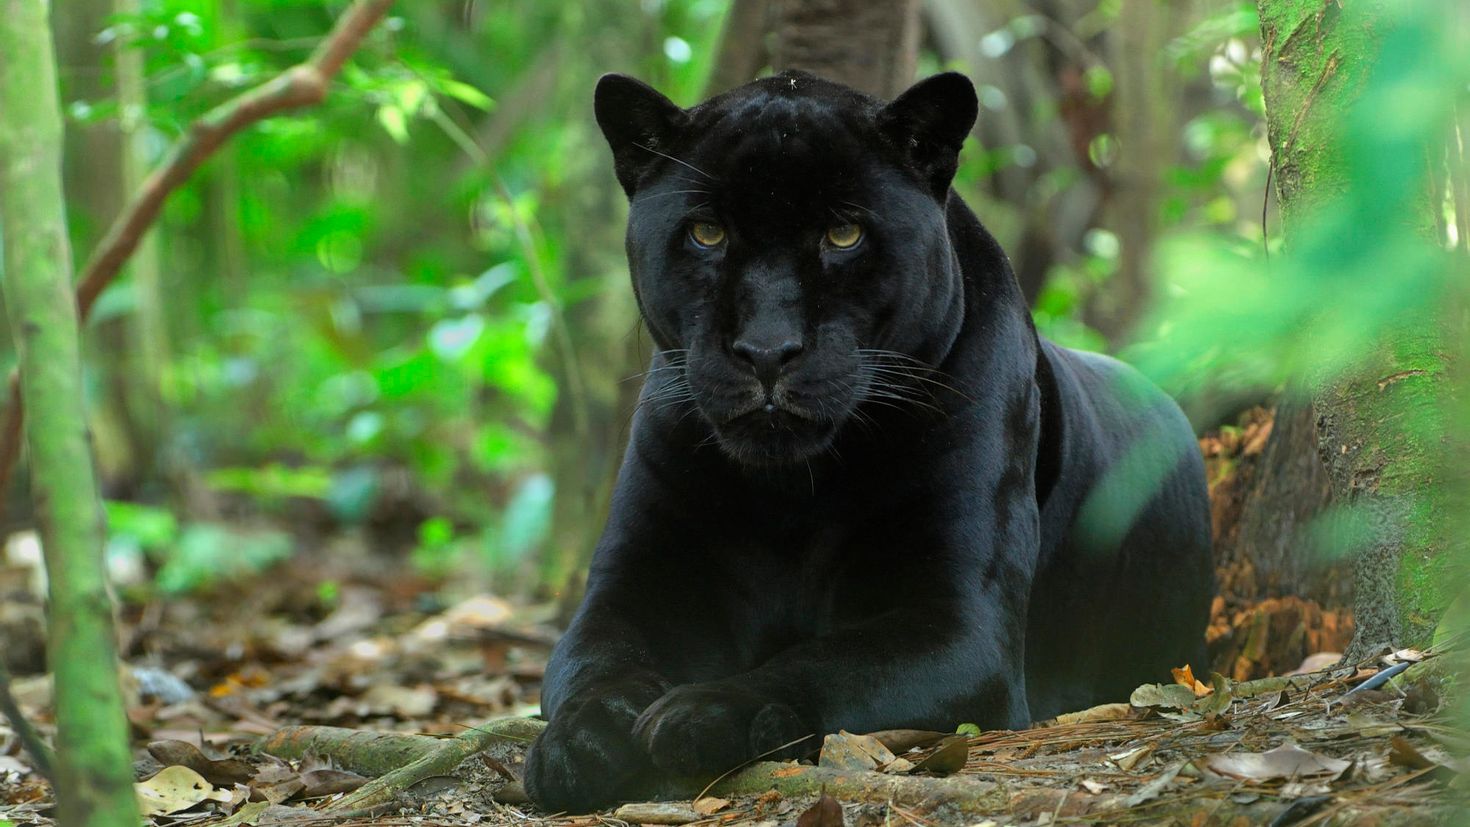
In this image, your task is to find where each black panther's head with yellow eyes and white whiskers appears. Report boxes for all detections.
[597,72,976,466]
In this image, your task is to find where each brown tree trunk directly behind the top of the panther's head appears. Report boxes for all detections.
[773,0,919,100]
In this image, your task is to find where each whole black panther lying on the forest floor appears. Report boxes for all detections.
[525,72,1213,811]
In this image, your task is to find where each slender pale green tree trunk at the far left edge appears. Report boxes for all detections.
[0,0,138,827]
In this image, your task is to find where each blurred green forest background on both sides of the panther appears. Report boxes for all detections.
[0,0,1466,625]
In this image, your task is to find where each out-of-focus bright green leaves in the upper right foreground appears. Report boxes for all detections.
[1133,4,1470,392]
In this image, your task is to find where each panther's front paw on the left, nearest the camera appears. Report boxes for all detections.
[522,685,662,812]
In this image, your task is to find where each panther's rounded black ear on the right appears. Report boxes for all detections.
[878,72,979,201]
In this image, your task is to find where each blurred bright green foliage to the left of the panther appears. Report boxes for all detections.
[47,0,726,589]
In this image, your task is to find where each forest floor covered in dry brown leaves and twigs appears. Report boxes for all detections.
[0,417,1470,827]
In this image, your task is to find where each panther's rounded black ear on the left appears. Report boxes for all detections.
[592,75,686,197]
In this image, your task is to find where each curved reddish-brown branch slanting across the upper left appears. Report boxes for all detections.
[0,0,392,516]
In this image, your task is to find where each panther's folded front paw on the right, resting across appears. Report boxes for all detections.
[634,683,816,776]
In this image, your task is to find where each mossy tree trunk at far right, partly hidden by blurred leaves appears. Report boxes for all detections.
[1258,0,1449,658]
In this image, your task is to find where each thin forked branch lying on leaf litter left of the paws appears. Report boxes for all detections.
[260,718,545,817]
